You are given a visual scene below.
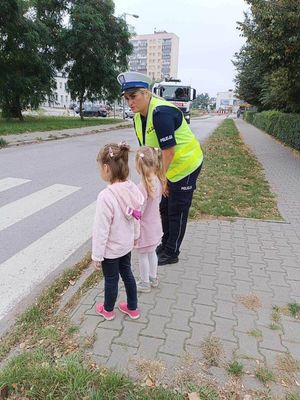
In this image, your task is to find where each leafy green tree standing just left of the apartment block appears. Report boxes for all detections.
[63,0,132,118]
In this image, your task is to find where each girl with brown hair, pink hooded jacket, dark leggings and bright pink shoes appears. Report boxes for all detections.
[92,143,144,320]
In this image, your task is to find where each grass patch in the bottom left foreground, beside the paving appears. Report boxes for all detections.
[0,350,186,400]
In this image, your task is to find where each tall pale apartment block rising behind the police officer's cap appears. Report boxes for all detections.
[129,31,179,80]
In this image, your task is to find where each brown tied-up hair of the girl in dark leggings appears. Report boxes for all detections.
[97,143,130,183]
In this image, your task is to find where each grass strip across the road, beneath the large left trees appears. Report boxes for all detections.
[0,116,123,136]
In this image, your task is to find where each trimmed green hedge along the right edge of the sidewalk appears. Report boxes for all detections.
[244,111,300,150]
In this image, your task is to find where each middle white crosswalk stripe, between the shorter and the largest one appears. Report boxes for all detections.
[0,184,80,231]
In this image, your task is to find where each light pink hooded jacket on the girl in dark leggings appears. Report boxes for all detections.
[92,180,144,261]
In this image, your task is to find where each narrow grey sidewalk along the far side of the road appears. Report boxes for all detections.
[2,122,132,148]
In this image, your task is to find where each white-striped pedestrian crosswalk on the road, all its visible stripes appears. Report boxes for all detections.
[0,178,95,323]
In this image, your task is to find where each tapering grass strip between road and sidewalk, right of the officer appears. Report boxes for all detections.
[190,119,282,220]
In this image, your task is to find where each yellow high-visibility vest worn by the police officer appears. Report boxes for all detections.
[134,96,203,182]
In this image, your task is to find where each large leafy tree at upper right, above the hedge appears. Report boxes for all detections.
[234,0,300,112]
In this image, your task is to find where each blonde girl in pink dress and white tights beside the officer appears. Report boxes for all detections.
[135,146,165,293]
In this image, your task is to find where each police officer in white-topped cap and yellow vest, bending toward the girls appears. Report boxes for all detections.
[118,72,203,265]
